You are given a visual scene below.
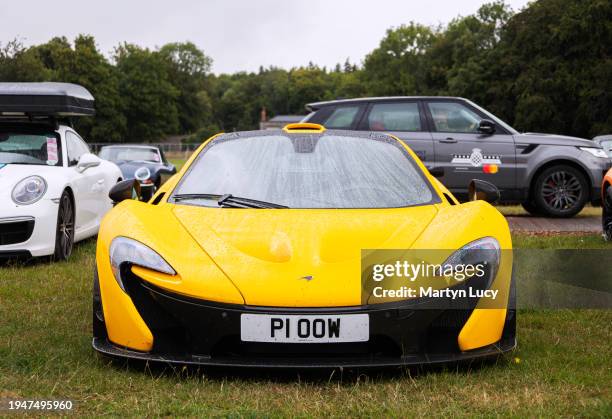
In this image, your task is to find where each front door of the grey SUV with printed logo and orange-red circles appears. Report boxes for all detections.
[426,100,516,200]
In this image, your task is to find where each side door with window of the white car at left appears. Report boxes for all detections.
[66,130,105,233]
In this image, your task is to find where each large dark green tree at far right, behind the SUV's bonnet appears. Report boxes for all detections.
[494,0,612,137]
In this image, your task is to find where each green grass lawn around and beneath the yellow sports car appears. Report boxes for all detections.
[0,235,612,417]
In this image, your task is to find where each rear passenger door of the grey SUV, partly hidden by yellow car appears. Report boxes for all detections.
[359,100,435,167]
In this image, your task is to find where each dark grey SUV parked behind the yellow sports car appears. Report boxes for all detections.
[304,96,611,217]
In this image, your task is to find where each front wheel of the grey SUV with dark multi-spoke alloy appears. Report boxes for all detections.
[532,164,589,218]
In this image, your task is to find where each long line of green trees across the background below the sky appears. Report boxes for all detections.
[0,0,612,142]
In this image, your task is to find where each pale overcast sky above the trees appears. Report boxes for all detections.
[0,0,527,73]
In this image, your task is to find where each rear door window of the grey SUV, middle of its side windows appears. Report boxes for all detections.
[368,103,421,131]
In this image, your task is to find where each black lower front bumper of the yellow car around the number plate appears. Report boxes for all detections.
[92,275,516,368]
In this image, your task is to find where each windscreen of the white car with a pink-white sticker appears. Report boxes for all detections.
[0,129,62,166]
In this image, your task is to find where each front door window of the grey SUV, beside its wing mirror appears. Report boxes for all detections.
[427,102,482,133]
